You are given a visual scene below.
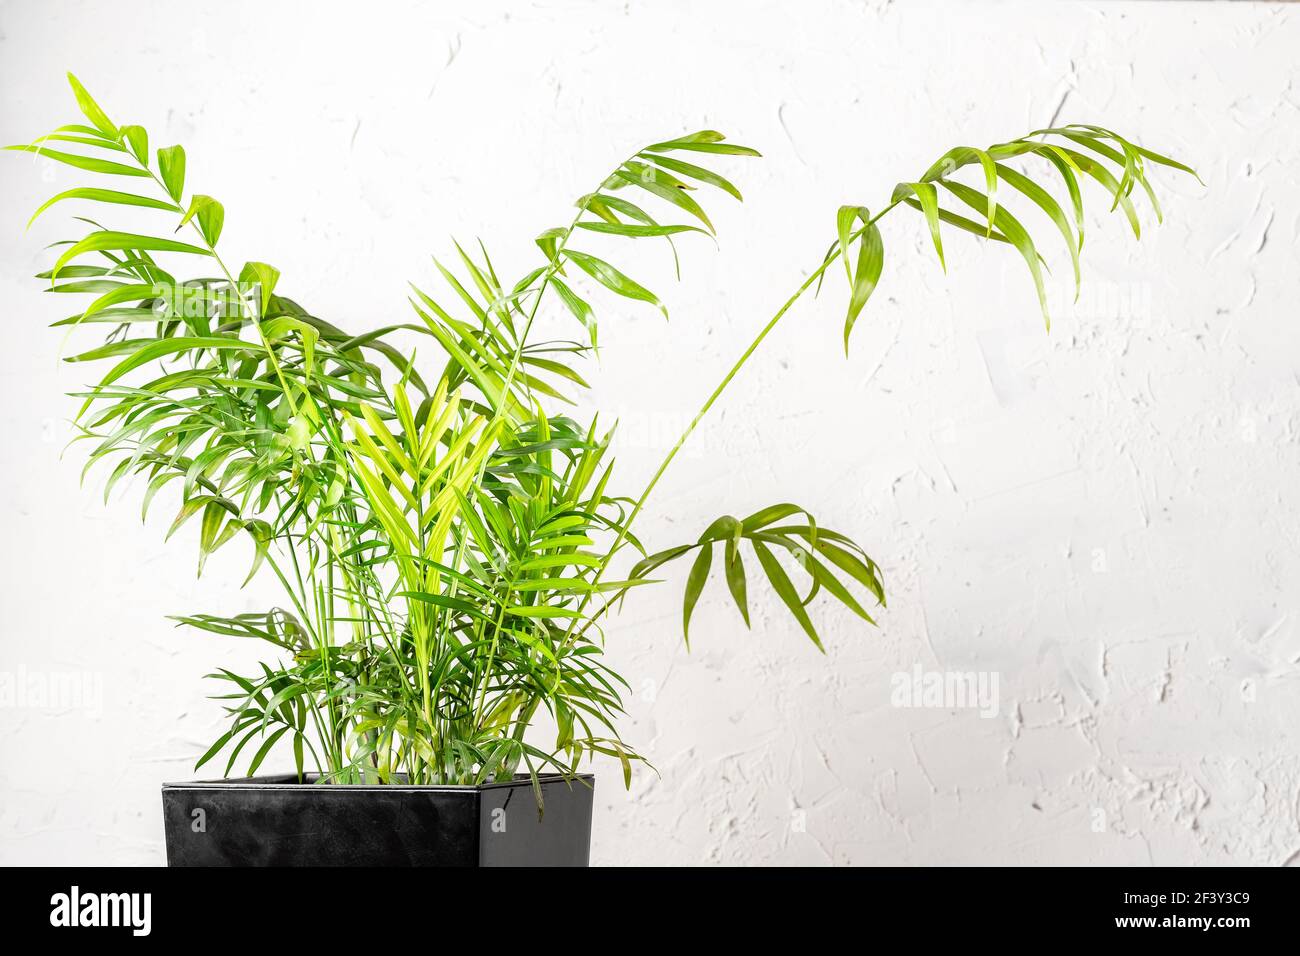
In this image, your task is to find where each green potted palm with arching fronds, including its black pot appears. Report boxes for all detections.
[9,75,1192,865]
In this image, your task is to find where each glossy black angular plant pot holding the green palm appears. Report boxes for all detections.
[163,774,595,866]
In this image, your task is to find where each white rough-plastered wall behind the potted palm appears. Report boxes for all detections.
[0,0,1300,864]
